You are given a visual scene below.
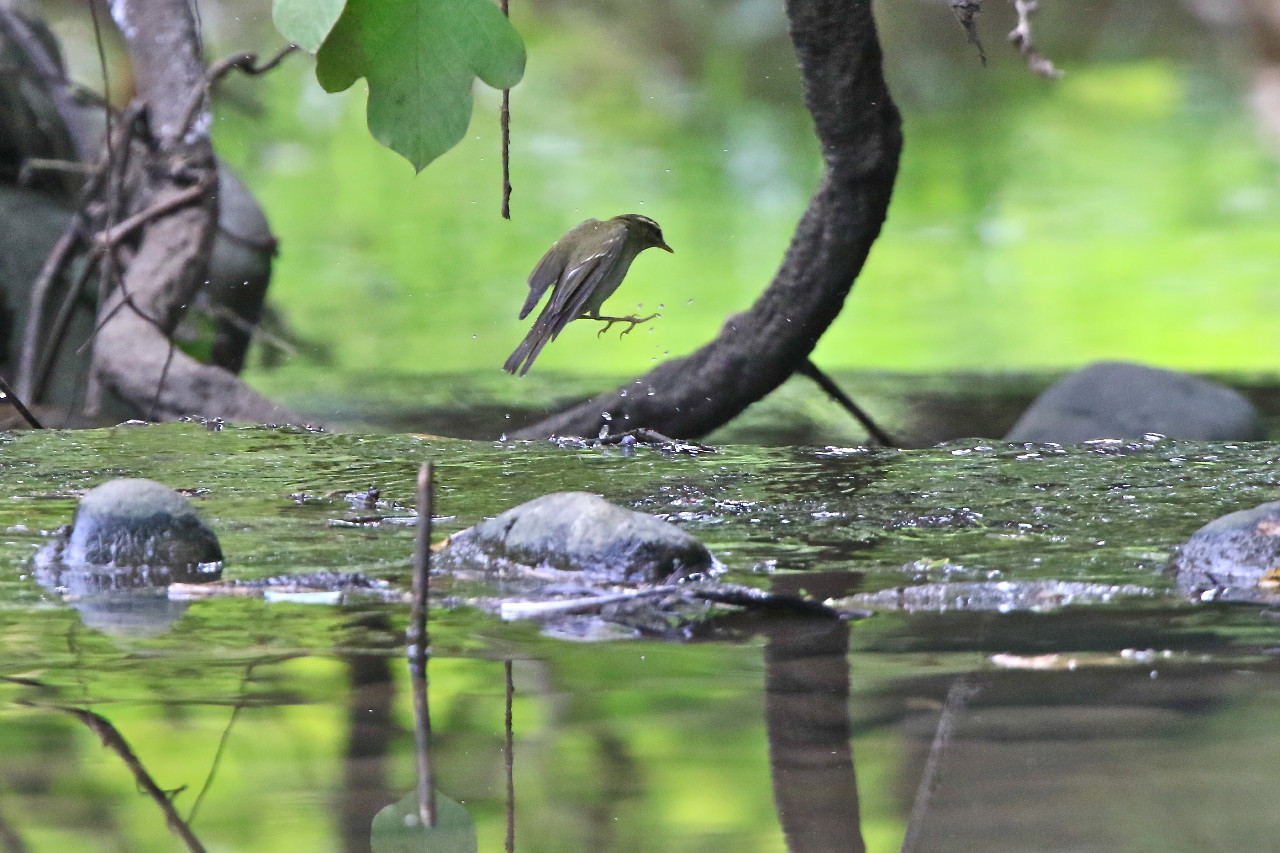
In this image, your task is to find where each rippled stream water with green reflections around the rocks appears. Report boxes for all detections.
[0,424,1280,852]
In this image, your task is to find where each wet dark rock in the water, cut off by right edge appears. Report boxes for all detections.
[1171,501,1280,601]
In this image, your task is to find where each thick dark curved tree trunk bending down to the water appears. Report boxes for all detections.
[516,0,902,438]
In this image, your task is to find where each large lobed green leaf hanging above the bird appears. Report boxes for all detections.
[316,0,525,170]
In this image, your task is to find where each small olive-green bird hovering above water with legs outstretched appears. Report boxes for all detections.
[502,214,675,375]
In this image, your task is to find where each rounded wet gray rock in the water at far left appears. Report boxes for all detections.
[41,479,223,571]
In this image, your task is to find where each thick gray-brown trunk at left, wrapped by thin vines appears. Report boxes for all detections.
[93,0,296,421]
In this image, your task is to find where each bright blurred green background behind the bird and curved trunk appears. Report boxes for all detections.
[40,0,1280,386]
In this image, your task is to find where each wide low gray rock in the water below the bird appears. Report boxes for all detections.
[435,492,717,583]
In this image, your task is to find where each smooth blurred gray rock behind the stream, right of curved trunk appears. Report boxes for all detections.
[1005,361,1261,443]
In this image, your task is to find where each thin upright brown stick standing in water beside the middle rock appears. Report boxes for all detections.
[410,462,435,826]
